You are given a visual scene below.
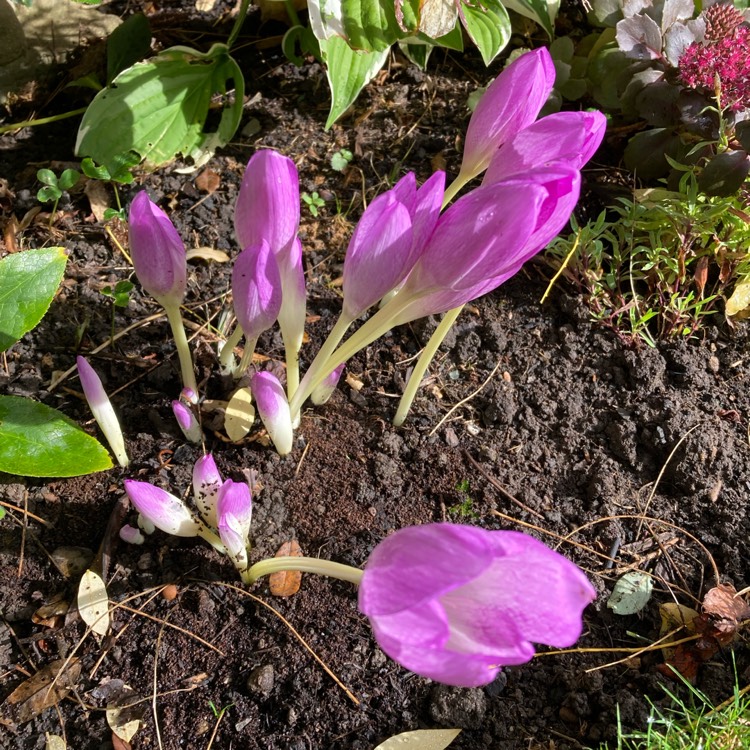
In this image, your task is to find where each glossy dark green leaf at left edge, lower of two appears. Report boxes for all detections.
[0,396,112,477]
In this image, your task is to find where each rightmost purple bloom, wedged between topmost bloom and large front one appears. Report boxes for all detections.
[482,112,607,185]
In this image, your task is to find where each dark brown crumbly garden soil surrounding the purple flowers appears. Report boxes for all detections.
[0,5,750,750]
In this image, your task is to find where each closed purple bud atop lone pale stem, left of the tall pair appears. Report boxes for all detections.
[128,191,187,307]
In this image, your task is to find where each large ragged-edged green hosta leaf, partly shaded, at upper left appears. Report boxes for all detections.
[76,44,245,175]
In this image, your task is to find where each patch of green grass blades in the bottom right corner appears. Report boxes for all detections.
[617,684,750,750]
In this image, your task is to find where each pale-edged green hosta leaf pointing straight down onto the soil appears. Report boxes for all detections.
[320,36,388,130]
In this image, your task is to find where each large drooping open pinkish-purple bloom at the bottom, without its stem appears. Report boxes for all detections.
[359,523,596,687]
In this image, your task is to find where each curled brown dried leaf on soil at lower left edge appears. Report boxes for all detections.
[2,658,81,724]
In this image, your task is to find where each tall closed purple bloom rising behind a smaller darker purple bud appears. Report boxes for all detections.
[234,149,300,262]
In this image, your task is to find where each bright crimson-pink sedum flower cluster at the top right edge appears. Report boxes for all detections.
[679,26,750,112]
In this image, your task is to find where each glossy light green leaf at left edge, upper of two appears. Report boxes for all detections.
[0,247,68,352]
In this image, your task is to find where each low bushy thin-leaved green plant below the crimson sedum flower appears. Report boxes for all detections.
[547,171,750,345]
